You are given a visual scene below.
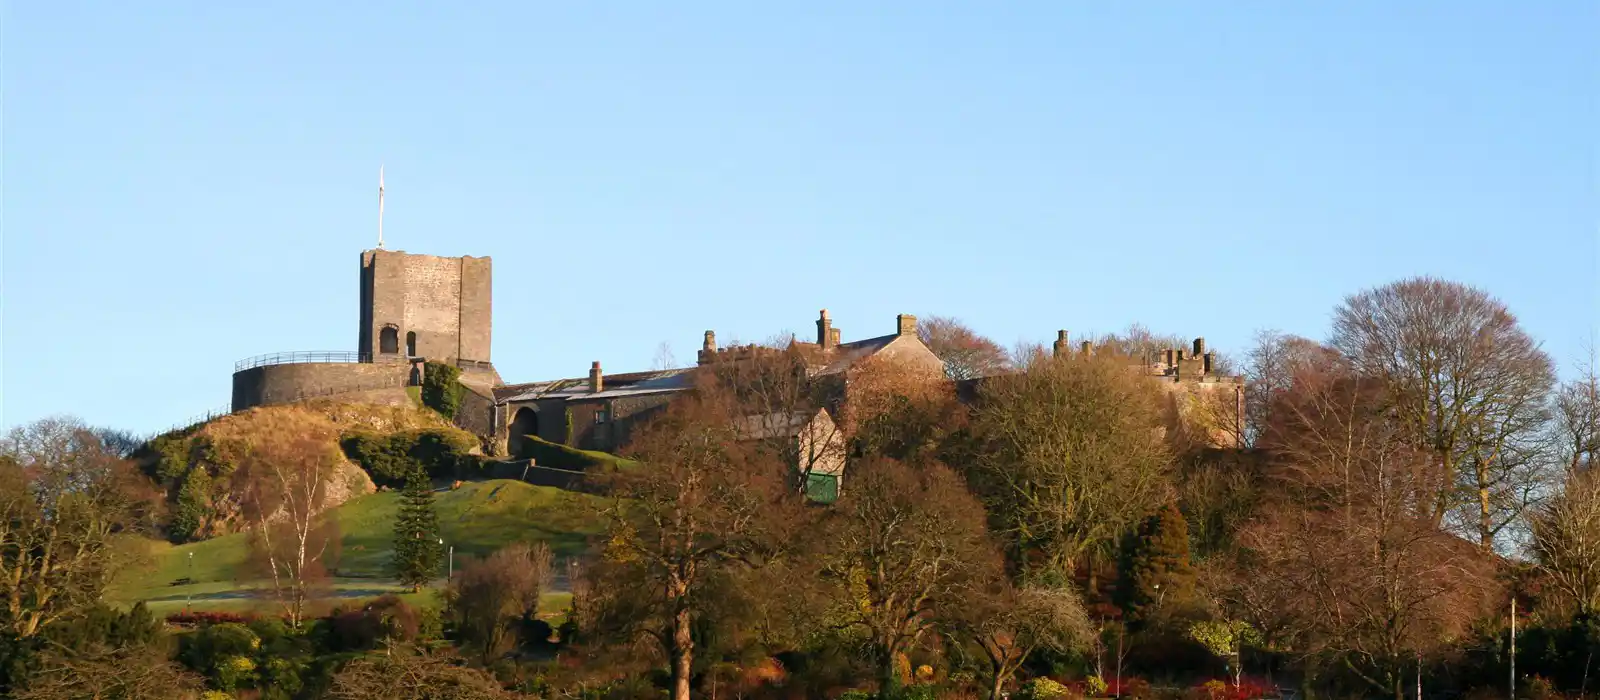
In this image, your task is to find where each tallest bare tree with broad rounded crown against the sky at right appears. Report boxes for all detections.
[1331,276,1555,550]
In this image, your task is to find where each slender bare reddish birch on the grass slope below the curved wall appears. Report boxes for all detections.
[227,414,344,630]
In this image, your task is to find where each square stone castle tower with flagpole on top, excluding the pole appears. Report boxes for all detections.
[357,249,491,363]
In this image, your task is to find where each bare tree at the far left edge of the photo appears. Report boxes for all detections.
[0,417,149,638]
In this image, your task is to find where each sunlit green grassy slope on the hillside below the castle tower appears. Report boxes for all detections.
[109,479,602,612]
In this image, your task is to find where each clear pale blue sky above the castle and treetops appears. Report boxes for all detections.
[0,0,1600,432]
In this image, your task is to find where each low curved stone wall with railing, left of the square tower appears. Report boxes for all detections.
[234,363,411,411]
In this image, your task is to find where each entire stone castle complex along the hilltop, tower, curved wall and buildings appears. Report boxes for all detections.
[232,249,1243,459]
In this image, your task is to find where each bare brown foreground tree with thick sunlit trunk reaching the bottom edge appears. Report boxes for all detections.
[603,385,792,700]
